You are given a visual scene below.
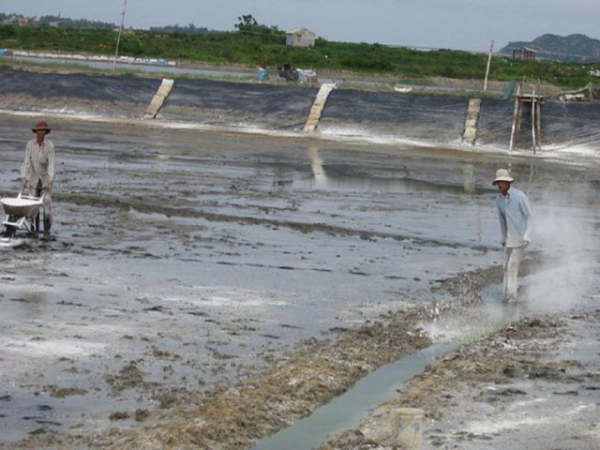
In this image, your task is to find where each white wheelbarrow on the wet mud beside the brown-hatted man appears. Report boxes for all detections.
[0,191,44,238]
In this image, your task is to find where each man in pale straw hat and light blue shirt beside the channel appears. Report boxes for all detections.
[492,169,533,302]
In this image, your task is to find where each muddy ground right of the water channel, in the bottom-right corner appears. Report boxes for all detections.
[322,305,600,450]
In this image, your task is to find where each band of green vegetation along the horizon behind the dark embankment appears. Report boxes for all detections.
[0,21,600,89]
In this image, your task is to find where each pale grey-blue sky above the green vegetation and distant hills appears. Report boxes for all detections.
[0,0,600,53]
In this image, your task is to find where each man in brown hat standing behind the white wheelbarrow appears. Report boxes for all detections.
[21,120,54,240]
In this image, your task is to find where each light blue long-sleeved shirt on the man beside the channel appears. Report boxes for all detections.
[496,187,533,248]
